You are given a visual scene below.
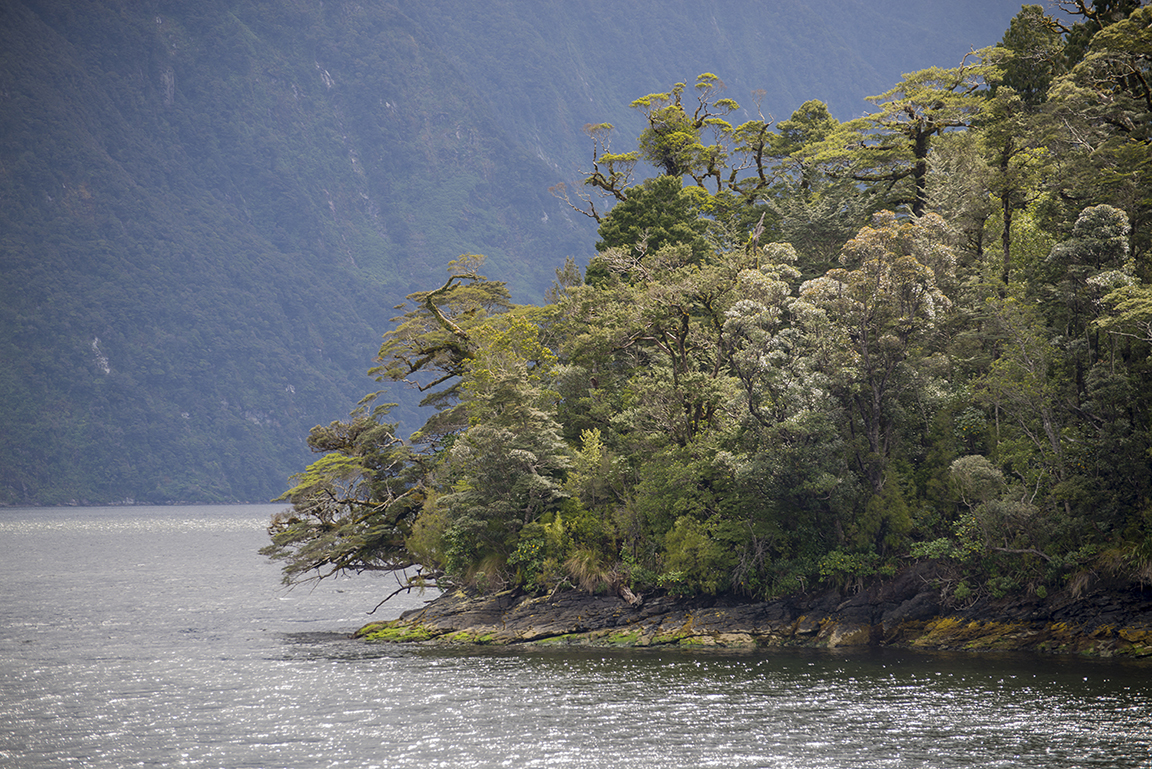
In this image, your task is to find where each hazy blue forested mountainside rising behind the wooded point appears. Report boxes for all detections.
[0,0,1041,504]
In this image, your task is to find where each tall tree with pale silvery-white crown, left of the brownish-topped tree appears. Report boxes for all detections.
[717,244,854,584]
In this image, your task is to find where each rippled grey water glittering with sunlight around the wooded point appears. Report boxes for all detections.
[0,505,1152,769]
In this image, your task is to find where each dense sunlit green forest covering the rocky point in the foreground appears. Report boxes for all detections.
[265,0,1152,601]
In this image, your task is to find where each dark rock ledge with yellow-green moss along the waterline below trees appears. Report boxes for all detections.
[356,569,1152,657]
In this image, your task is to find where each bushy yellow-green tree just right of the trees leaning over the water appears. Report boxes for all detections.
[405,291,570,587]
